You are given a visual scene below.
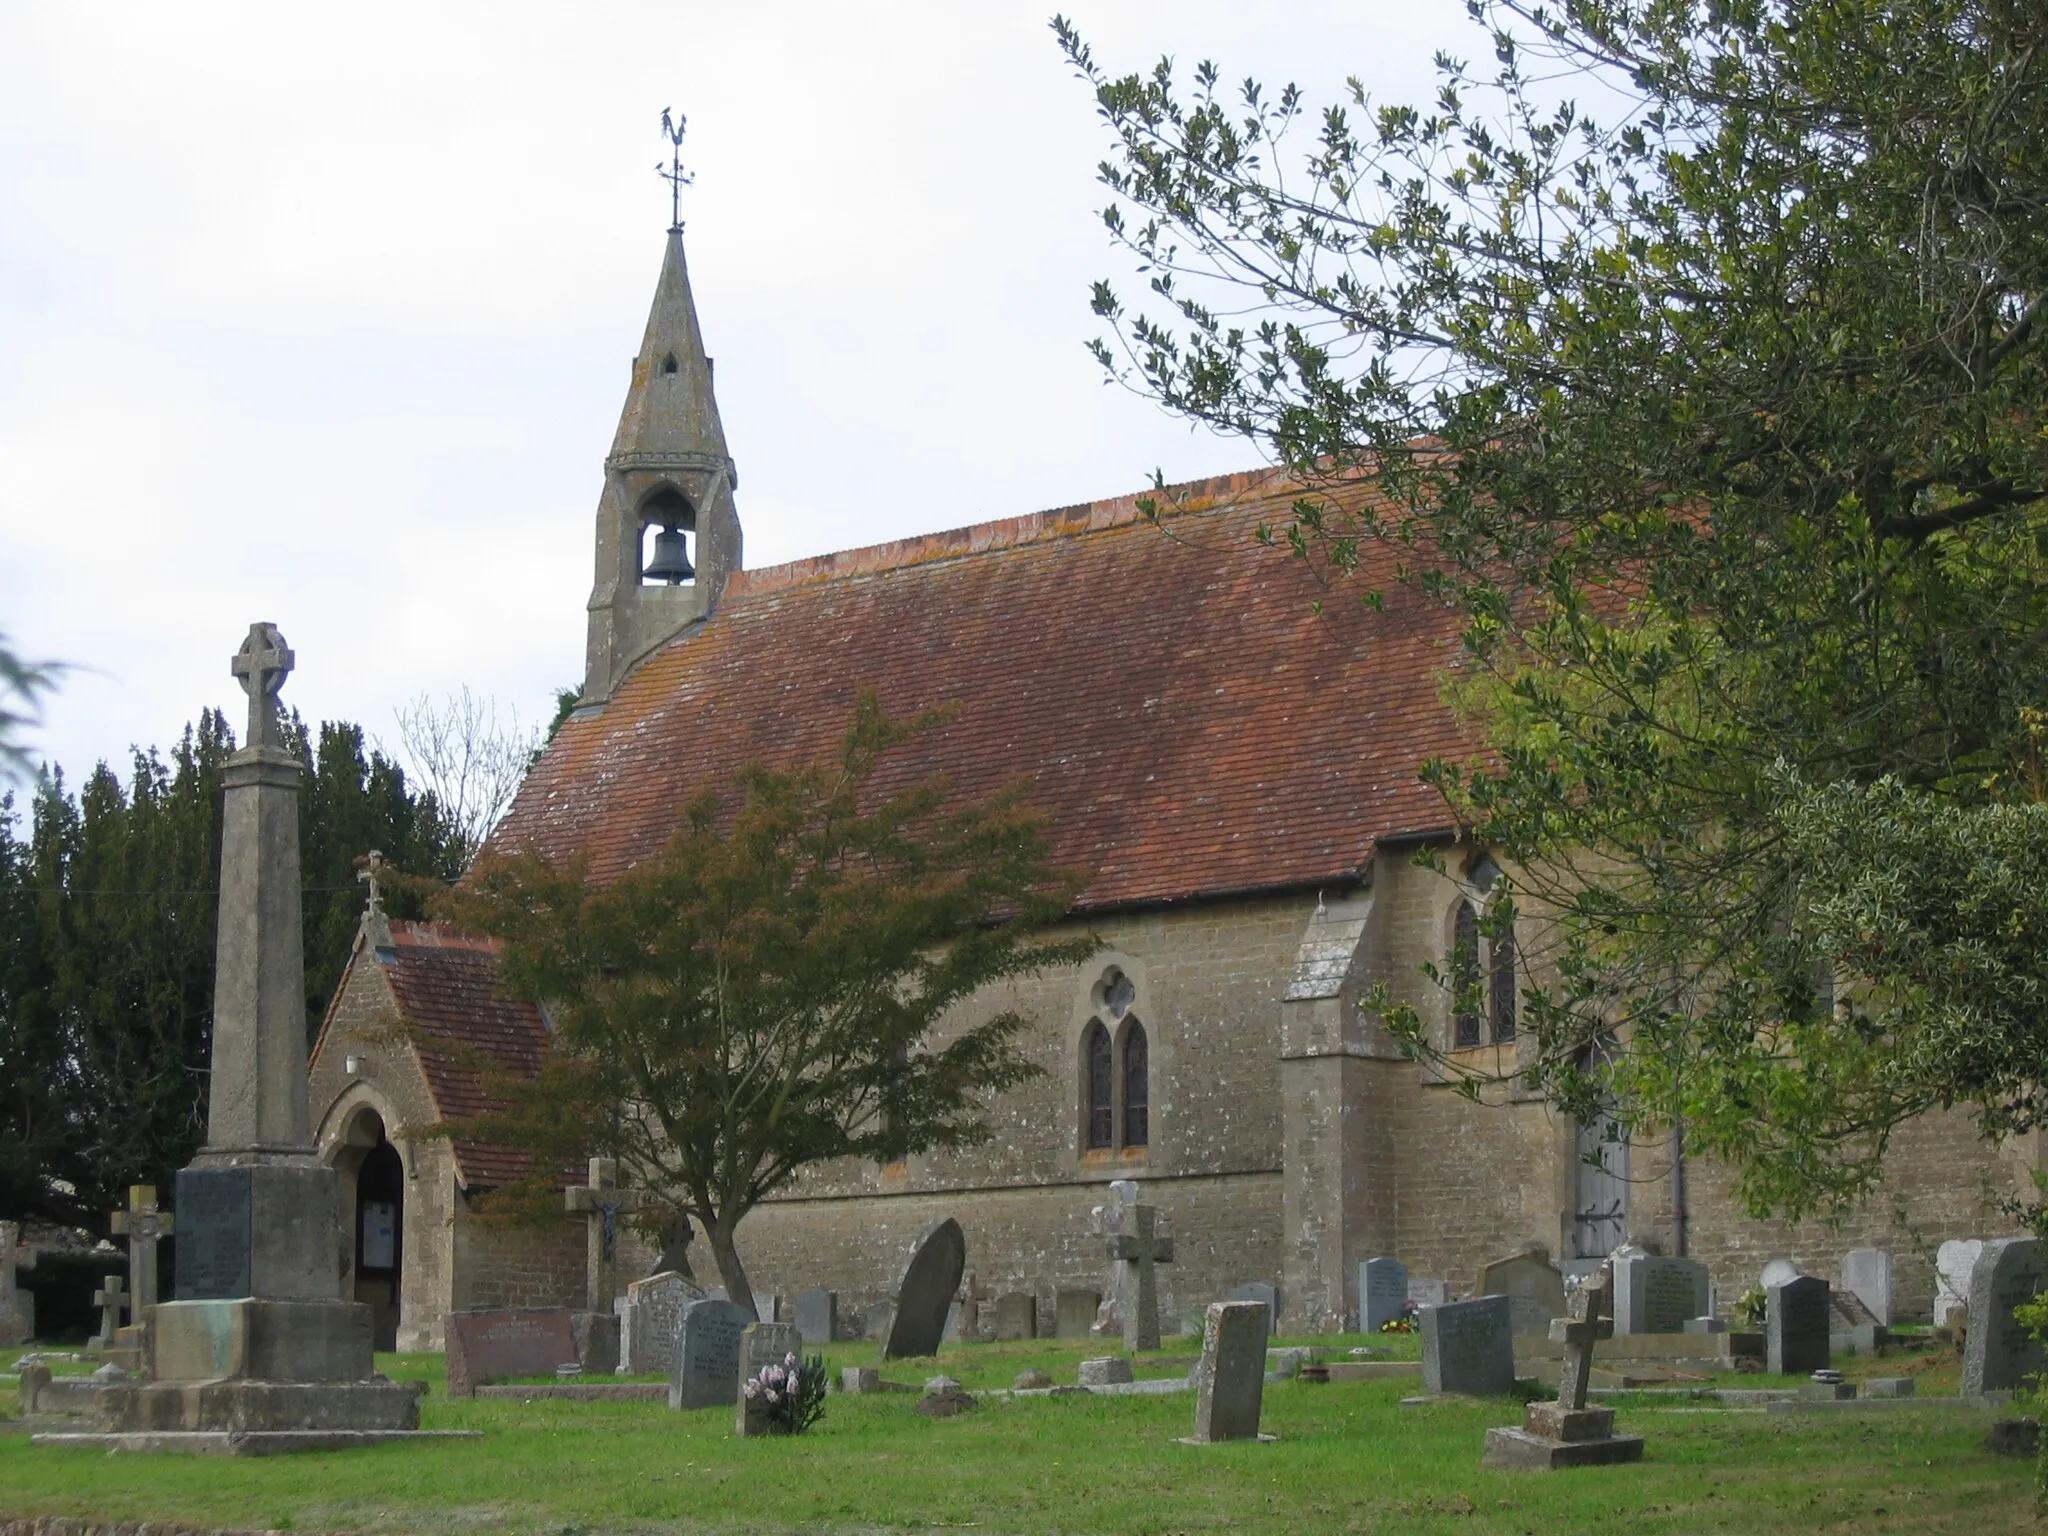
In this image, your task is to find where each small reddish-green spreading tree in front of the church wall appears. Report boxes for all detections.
[446,696,1096,1309]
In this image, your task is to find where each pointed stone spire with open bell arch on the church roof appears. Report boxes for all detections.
[584,229,739,702]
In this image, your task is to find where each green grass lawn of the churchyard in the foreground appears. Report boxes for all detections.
[0,1339,2034,1536]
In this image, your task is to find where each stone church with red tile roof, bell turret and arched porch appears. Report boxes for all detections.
[311,233,2040,1348]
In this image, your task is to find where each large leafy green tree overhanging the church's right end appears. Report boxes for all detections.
[1055,0,2048,1212]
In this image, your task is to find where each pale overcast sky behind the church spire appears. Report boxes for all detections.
[0,0,1483,794]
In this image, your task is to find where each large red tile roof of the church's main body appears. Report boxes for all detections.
[498,473,1468,909]
